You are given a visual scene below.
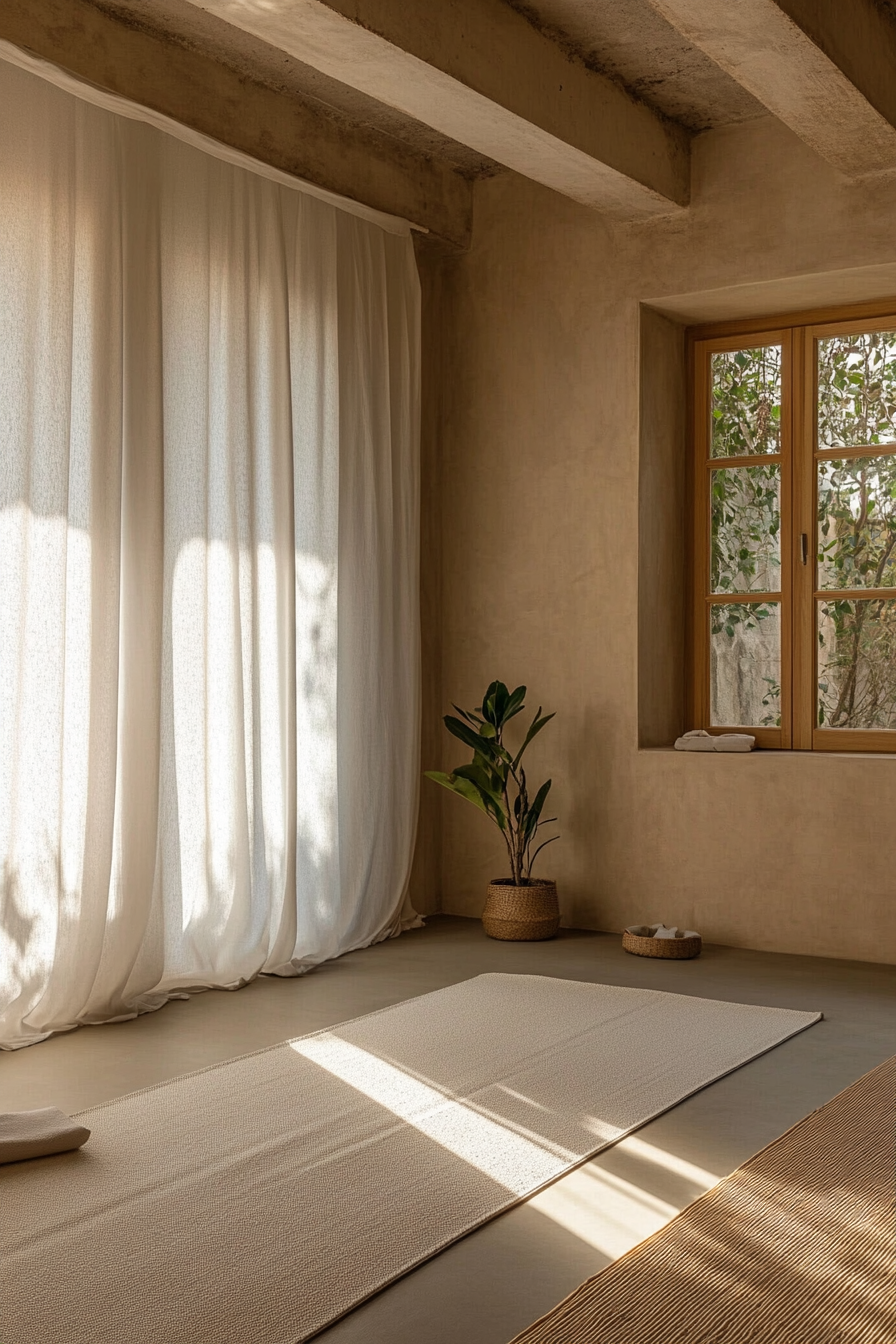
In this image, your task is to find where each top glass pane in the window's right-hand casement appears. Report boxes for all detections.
[818,332,896,448]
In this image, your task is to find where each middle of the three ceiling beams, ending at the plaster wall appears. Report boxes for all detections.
[192,0,690,218]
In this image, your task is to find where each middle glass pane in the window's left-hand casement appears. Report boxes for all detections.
[711,462,780,593]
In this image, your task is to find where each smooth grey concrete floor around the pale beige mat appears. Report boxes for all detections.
[0,915,896,1344]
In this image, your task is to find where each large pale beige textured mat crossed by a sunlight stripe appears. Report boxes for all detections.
[0,974,821,1344]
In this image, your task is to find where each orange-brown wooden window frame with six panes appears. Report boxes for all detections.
[686,298,896,753]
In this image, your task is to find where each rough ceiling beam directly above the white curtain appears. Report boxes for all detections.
[0,0,473,251]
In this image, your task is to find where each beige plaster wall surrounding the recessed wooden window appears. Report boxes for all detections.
[423,118,896,961]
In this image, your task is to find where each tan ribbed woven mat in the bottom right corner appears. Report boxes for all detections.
[513,1056,896,1344]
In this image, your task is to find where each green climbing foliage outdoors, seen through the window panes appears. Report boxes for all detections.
[711,332,896,728]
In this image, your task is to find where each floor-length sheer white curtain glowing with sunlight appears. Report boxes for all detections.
[0,49,419,1048]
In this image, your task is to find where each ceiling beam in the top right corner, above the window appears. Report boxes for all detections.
[650,0,896,177]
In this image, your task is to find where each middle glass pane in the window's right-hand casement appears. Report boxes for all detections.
[818,454,896,589]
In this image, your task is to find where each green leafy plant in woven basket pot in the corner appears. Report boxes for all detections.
[426,681,560,941]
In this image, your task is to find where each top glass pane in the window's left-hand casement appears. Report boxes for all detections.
[709,345,780,457]
